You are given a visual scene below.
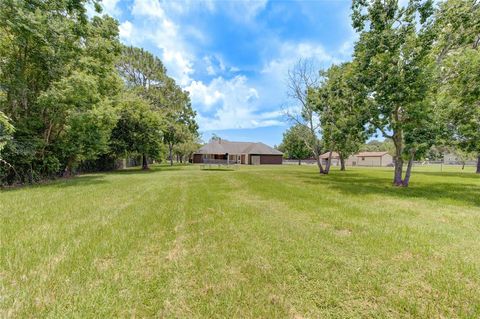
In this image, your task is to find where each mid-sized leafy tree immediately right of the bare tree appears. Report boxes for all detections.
[309,63,367,173]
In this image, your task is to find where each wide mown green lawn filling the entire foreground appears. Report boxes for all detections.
[0,165,480,318]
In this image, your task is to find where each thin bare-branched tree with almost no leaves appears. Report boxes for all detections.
[285,59,326,174]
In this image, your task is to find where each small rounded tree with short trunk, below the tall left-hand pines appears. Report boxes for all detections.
[110,94,163,170]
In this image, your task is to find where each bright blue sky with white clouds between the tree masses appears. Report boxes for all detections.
[96,0,356,145]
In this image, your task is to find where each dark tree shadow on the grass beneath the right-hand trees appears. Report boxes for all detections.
[297,171,480,206]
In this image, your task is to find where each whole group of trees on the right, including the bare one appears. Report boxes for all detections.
[286,0,480,187]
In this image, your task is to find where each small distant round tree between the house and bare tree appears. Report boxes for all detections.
[278,124,312,165]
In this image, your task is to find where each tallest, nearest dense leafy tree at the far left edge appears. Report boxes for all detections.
[0,0,121,182]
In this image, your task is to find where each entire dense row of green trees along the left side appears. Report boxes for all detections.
[0,0,199,184]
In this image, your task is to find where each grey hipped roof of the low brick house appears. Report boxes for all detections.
[196,140,283,155]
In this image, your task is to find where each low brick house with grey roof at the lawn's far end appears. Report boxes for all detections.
[192,139,283,165]
